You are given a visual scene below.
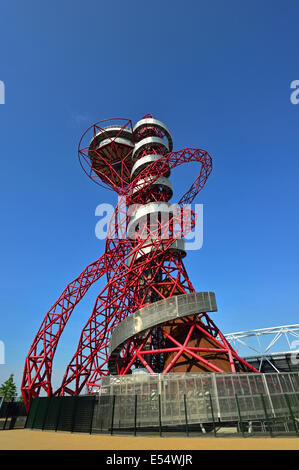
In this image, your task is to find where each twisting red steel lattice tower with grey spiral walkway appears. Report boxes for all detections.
[22,115,257,408]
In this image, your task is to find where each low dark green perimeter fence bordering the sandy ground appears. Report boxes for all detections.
[25,393,299,437]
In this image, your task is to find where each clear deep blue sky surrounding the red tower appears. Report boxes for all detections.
[0,0,299,392]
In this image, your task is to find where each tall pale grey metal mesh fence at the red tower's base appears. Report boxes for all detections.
[93,373,299,432]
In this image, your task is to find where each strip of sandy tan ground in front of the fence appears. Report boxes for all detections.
[0,429,299,451]
